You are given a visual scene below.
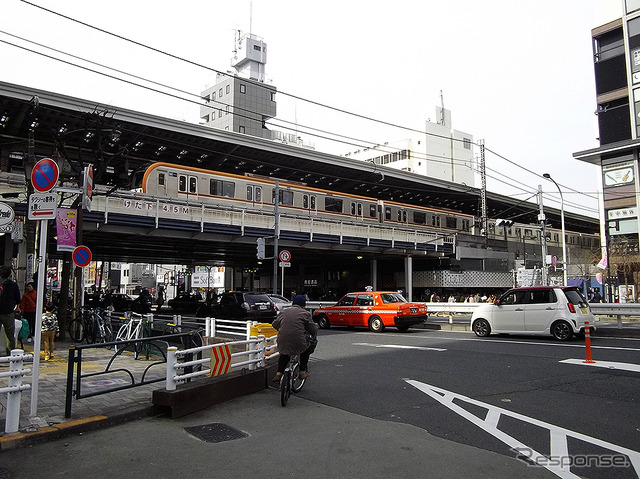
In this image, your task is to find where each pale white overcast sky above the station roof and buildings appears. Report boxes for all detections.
[0,0,621,216]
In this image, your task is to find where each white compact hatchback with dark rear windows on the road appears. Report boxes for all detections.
[471,286,595,341]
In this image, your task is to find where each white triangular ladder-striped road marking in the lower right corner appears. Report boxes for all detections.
[405,379,640,479]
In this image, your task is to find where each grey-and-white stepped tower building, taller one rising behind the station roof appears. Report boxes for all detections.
[200,30,277,139]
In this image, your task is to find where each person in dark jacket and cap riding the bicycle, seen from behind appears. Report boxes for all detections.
[273,295,318,383]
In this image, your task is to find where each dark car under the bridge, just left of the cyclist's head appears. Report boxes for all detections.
[196,292,278,323]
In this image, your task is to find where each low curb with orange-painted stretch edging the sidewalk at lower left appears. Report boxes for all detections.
[0,406,158,452]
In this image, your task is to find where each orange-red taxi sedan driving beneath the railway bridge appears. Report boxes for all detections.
[313,291,427,333]
